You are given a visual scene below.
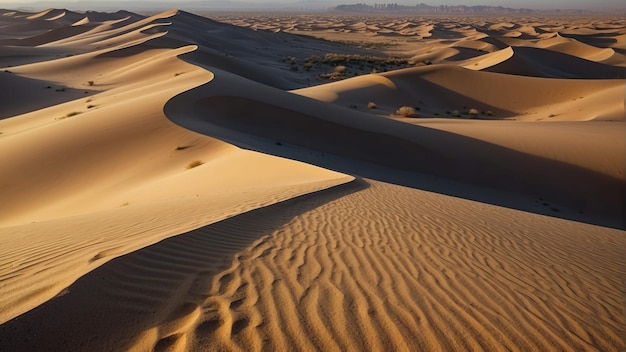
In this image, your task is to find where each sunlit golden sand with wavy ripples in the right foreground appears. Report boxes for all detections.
[176,183,626,351]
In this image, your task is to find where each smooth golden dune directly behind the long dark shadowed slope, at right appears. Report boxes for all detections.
[296,64,626,121]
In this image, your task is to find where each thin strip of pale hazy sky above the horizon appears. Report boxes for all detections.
[0,0,626,9]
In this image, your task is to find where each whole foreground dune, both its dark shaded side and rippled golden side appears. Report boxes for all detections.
[0,182,626,350]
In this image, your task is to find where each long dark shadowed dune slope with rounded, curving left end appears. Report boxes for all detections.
[165,70,625,228]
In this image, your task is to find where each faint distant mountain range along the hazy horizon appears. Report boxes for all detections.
[333,3,592,15]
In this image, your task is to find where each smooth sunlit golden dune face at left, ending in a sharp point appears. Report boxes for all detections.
[0,8,350,320]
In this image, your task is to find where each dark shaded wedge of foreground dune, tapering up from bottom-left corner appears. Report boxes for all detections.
[0,180,367,351]
